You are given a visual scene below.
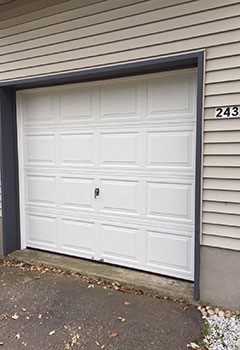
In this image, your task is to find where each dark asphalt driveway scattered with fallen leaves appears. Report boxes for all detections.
[0,264,202,350]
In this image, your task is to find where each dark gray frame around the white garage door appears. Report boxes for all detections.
[0,51,204,299]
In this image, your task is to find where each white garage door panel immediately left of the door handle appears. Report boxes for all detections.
[58,176,94,211]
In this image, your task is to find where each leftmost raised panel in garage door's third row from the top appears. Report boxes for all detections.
[26,175,56,206]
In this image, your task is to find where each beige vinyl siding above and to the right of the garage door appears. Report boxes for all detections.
[0,0,240,249]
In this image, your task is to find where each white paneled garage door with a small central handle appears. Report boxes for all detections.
[18,70,196,280]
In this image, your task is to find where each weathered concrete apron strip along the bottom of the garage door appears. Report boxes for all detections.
[5,249,198,305]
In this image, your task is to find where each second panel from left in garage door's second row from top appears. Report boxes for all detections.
[60,133,95,166]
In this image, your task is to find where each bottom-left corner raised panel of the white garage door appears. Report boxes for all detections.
[27,214,57,249]
